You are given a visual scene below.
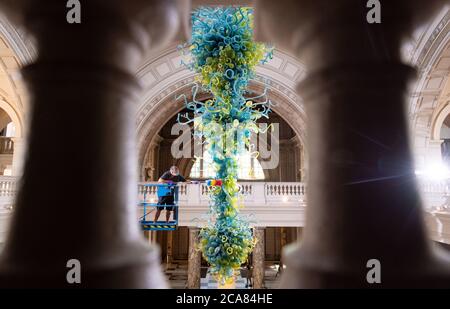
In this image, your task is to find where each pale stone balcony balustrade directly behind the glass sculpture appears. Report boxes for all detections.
[138,182,306,227]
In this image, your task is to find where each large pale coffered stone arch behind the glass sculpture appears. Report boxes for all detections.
[136,46,306,177]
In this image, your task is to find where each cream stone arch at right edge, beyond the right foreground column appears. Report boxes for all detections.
[409,7,450,166]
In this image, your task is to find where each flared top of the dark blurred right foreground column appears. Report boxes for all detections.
[255,0,445,72]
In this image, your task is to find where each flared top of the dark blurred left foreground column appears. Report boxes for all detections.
[0,0,185,74]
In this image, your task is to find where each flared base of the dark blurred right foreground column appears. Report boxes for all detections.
[280,244,450,289]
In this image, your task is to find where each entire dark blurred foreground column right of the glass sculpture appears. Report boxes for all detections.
[256,0,450,288]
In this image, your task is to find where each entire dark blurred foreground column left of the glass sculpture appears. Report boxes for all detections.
[0,0,183,288]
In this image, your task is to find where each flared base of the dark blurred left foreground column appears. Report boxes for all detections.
[0,241,168,289]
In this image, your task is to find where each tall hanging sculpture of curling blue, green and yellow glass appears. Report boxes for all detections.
[178,7,272,284]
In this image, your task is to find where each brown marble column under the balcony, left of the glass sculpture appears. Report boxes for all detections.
[187,227,202,289]
